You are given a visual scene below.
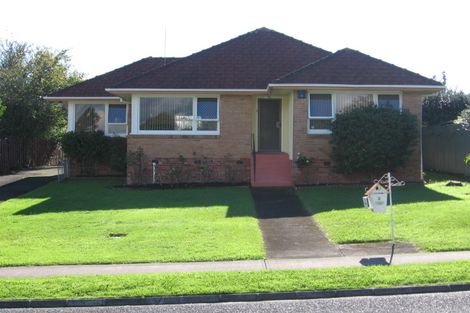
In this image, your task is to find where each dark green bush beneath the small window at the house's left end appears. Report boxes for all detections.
[61,131,127,171]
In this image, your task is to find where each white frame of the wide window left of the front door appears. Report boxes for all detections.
[132,94,220,136]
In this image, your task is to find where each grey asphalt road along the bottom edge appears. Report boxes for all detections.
[1,291,470,313]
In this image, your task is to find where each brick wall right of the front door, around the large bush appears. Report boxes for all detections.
[293,93,422,184]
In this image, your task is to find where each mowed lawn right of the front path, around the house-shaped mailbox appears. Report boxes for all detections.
[298,175,470,251]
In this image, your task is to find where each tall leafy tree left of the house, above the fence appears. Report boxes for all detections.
[0,41,83,141]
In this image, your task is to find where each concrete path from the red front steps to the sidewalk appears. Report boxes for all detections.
[252,188,341,259]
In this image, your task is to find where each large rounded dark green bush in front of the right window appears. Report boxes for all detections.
[331,106,418,175]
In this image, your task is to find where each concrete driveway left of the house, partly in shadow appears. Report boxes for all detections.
[0,167,57,202]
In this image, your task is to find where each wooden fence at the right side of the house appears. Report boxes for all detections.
[423,124,470,176]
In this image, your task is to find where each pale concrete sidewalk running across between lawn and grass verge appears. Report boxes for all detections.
[0,251,470,278]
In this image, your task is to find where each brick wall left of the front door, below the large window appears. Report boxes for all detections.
[127,95,252,184]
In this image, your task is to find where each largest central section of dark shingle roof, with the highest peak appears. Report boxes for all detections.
[114,28,330,89]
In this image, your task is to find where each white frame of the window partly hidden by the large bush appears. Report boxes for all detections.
[307,90,403,135]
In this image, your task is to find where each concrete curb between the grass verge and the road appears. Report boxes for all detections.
[0,283,470,309]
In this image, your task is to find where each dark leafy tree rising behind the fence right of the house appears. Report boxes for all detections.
[423,72,470,125]
